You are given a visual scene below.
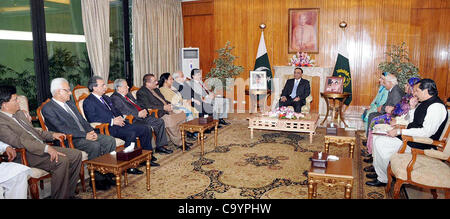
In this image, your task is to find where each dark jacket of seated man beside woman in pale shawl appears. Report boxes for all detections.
[136,86,170,118]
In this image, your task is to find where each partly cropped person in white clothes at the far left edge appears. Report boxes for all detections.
[0,141,31,199]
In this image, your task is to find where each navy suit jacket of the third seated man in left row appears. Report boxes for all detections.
[83,93,122,123]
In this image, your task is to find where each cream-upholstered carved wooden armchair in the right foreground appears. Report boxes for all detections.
[386,110,450,199]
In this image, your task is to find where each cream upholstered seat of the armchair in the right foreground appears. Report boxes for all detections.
[391,153,450,188]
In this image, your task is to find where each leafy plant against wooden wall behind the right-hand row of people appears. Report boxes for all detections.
[378,42,420,89]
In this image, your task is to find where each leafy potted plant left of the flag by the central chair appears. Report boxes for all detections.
[206,41,244,93]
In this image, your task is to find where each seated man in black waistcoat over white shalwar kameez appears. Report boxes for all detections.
[366,79,448,186]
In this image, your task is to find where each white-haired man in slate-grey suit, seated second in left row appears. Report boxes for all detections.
[41,78,116,190]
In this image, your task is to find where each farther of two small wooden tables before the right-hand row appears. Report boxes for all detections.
[325,128,357,158]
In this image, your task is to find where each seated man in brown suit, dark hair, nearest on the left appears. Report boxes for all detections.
[0,85,81,199]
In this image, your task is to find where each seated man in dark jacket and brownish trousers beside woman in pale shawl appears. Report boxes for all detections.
[136,74,188,153]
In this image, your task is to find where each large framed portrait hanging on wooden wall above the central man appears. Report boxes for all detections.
[288,8,320,53]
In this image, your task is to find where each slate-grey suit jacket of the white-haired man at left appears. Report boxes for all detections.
[42,100,94,138]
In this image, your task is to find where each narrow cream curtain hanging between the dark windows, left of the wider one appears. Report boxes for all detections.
[81,0,110,83]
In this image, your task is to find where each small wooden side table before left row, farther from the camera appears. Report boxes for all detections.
[180,118,219,156]
